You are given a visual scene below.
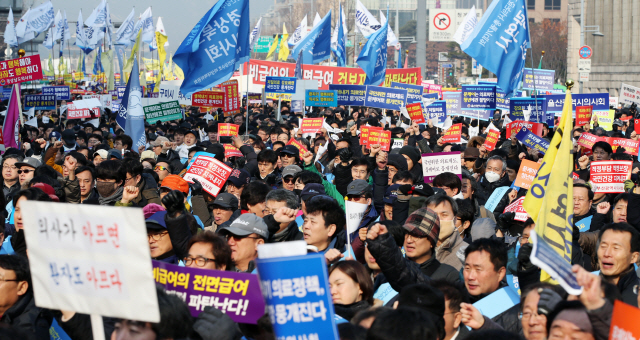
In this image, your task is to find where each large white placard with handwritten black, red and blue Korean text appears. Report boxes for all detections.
[20,201,160,322]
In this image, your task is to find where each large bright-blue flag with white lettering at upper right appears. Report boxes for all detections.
[460,0,530,98]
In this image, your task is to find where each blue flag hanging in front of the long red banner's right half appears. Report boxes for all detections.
[357,23,389,85]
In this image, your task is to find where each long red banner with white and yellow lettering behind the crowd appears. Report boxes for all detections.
[242,59,422,90]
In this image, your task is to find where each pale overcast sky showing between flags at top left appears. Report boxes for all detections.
[35,0,273,52]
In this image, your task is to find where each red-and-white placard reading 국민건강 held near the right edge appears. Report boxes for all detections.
[589,161,633,194]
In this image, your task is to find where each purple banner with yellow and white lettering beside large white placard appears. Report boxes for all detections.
[152,261,265,324]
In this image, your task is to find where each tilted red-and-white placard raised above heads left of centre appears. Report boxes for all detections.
[183,151,232,197]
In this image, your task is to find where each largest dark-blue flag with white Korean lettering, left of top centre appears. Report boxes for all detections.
[173,0,251,96]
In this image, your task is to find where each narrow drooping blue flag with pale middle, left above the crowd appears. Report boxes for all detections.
[120,57,147,150]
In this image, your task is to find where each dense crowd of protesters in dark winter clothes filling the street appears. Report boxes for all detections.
[0,95,640,340]
